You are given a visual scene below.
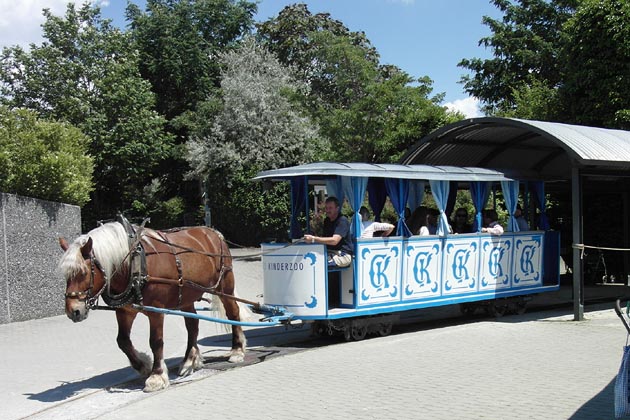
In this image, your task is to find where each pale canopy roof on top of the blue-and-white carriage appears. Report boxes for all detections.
[254,162,515,181]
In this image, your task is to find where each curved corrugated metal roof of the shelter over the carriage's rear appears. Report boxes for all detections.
[401,117,630,179]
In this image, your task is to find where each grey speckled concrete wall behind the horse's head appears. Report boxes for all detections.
[0,193,81,324]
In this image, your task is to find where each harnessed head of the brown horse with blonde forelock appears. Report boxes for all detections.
[59,236,105,322]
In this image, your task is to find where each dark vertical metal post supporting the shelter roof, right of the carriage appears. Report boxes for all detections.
[571,166,584,321]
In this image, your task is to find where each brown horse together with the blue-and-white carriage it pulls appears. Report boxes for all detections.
[60,163,560,391]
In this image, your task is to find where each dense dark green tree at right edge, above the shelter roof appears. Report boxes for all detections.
[559,0,630,130]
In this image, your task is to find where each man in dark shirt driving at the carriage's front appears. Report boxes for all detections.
[304,196,354,267]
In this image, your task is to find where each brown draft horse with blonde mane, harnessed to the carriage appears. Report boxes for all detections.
[59,222,246,392]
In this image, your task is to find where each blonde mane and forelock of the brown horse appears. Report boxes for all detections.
[59,222,129,280]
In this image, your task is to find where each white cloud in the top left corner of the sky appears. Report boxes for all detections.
[0,0,109,48]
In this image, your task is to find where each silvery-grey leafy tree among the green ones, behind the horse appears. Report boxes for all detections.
[188,39,326,183]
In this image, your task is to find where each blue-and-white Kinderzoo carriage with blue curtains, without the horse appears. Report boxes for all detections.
[256,162,560,340]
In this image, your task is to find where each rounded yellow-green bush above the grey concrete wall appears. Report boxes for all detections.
[0,106,93,206]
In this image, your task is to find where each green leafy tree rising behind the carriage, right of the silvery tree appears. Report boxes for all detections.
[258,4,462,162]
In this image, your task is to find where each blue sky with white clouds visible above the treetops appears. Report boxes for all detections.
[0,0,500,117]
